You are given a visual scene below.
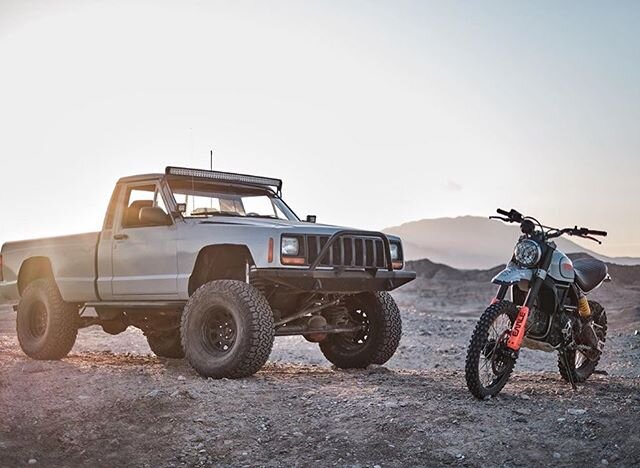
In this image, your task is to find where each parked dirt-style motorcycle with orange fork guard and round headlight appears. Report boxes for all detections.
[465,209,611,399]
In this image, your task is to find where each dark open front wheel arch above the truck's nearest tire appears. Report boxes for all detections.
[188,244,255,296]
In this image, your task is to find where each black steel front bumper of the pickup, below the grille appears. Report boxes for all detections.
[251,268,416,293]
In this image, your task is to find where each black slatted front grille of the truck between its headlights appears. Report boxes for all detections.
[303,235,387,268]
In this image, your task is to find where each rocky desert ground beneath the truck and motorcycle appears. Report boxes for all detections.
[0,272,640,467]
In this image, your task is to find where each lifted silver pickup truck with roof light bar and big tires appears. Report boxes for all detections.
[0,167,415,378]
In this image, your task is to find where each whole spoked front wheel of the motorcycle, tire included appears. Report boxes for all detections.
[465,301,518,399]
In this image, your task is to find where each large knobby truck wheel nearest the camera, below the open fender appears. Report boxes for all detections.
[180,280,274,379]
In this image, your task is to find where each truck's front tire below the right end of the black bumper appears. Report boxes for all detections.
[320,292,402,369]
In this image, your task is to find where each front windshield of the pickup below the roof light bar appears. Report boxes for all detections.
[169,180,298,221]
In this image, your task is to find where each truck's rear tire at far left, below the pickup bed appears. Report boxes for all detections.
[16,278,79,360]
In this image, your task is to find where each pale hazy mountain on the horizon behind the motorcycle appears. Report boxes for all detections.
[384,216,640,269]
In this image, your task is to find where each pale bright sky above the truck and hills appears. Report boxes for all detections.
[0,0,640,256]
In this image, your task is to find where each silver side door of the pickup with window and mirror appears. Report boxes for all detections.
[111,182,178,300]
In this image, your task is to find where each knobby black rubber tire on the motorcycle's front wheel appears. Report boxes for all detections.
[464,301,518,399]
